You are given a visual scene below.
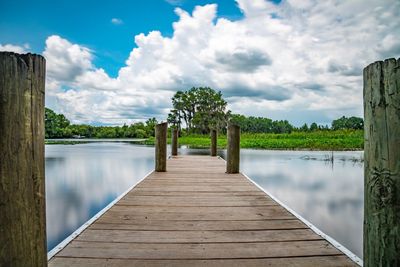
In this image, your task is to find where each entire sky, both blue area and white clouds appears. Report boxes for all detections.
[0,0,400,125]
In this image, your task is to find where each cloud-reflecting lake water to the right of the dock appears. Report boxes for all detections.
[236,149,364,258]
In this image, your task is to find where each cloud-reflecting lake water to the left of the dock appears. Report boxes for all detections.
[46,143,154,250]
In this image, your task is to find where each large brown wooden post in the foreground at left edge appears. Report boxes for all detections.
[0,52,47,266]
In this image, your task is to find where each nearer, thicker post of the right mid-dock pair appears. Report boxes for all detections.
[226,124,240,173]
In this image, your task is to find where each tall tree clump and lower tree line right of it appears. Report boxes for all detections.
[168,87,364,134]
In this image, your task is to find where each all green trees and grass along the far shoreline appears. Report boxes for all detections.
[45,87,364,150]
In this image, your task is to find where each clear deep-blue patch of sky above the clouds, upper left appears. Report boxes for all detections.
[0,0,247,77]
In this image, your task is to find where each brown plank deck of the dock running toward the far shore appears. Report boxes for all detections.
[50,156,355,266]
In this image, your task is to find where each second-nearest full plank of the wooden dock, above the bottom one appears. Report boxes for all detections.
[54,240,341,259]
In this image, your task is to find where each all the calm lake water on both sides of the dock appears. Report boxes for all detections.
[46,142,364,257]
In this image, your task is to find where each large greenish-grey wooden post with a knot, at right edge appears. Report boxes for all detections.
[364,59,400,267]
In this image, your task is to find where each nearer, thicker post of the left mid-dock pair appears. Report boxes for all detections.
[155,122,168,172]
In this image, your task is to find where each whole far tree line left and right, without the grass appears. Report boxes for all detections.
[45,87,364,138]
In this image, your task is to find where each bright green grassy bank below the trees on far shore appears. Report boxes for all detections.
[145,130,364,150]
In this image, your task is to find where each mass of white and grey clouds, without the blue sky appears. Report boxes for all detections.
[44,0,400,125]
